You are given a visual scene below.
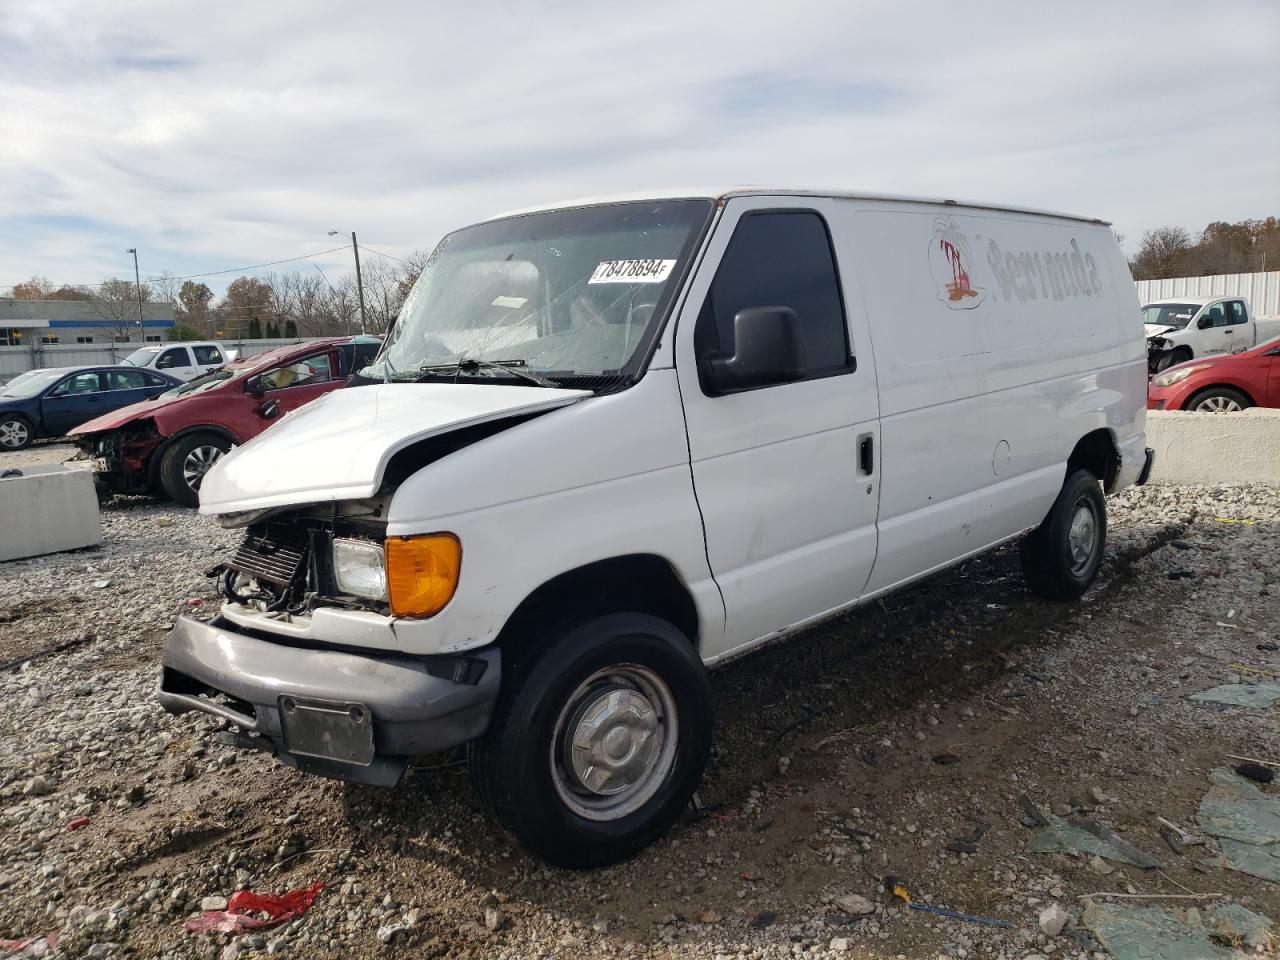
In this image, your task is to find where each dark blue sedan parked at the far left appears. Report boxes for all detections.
[0,366,182,451]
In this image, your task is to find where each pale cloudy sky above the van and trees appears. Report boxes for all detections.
[0,0,1280,292]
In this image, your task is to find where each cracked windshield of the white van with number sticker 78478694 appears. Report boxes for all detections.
[360,200,713,389]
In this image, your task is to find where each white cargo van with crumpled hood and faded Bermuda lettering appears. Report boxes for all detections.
[159,189,1151,867]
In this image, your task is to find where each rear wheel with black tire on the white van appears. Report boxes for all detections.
[1019,470,1107,600]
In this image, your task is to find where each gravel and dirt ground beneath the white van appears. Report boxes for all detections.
[0,463,1280,960]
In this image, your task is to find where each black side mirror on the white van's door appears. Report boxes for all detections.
[705,307,805,394]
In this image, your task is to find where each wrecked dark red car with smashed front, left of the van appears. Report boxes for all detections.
[68,337,381,507]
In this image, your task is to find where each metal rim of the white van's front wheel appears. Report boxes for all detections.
[549,663,680,820]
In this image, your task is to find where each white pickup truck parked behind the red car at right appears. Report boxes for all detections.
[1142,297,1280,374]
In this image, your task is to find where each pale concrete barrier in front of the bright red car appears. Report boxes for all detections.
[1147,407,1280,486]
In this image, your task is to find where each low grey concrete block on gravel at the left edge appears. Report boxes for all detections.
[0,463,102,561]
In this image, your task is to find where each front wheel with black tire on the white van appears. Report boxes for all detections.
[471,613,712,869]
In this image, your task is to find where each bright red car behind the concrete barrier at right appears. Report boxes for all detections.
[1147,339,1280,413]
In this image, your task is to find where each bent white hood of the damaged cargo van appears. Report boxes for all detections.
[200,383,591,515]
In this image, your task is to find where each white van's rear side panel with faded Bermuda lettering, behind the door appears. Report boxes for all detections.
[838,201,1146,593]
